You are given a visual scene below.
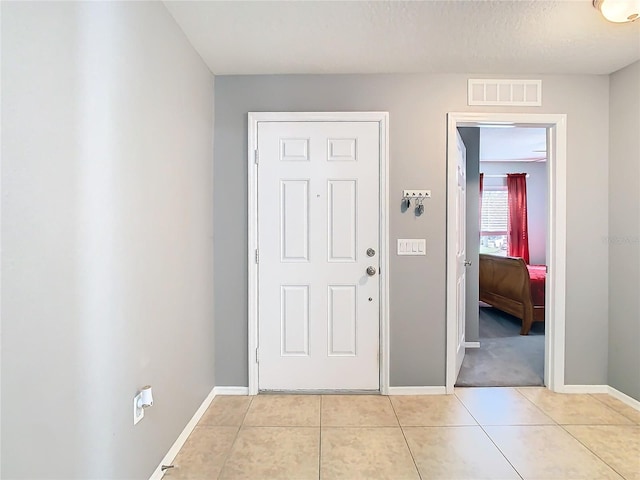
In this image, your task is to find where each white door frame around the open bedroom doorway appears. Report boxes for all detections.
[446,112,567,393]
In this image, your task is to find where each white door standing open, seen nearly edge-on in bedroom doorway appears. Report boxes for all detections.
[455,130,467,378]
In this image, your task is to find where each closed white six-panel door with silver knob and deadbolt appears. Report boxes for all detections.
[258,121,380,390]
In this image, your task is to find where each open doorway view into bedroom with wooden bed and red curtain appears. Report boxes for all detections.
[455,125,548,387]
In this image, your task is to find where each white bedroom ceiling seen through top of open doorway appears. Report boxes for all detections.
[480,127,547,162]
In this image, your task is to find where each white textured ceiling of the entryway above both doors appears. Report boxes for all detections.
[164,0,640,75]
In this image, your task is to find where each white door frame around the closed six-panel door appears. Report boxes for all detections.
[247,112,389,395]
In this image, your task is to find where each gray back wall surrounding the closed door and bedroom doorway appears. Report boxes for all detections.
[214,74,609,386]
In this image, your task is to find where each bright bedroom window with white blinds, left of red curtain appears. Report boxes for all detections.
[480,187,509,257]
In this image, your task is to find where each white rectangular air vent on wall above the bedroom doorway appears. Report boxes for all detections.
[467,78,542,107]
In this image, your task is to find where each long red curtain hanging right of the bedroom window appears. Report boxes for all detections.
[507,173,529,264]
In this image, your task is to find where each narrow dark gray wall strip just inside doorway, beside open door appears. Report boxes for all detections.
[458,127,480,342]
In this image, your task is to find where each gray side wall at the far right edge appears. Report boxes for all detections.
[602,61,640,400]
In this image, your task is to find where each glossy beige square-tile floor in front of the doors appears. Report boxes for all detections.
[164,387,640,480]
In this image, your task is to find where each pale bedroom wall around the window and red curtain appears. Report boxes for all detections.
[480,162,549,265]
